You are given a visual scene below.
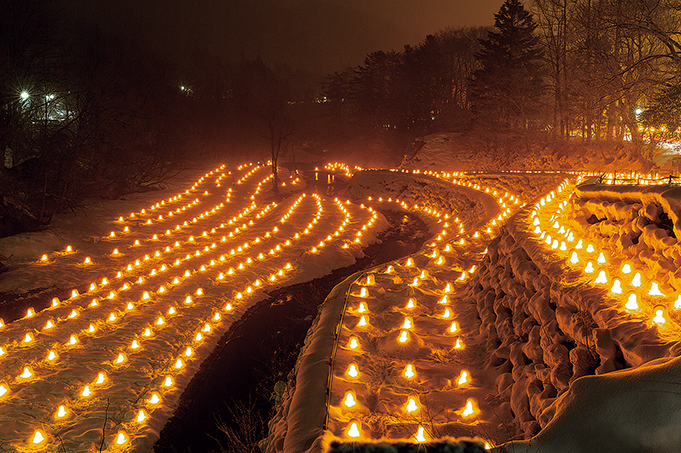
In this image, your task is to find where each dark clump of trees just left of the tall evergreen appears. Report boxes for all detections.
[324,27,487,132]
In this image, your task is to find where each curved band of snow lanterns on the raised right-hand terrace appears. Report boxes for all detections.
[531,181,681,327]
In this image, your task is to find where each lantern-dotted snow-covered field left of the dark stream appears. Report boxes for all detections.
[0,164,385,451]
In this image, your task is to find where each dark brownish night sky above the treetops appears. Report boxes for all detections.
[70,0,503,74]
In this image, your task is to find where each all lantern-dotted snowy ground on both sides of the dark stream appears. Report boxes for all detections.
[0,136,681,453]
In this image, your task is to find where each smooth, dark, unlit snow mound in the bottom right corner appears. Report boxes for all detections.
[494,357,681,453]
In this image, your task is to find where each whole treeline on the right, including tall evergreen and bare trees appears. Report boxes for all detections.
[325,0,681,151]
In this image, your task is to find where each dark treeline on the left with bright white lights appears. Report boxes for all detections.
[0,0,302,237]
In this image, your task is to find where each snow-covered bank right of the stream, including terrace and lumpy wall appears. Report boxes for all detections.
[267,135,681,453]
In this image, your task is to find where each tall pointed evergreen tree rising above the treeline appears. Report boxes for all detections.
[471,0,544,130]
